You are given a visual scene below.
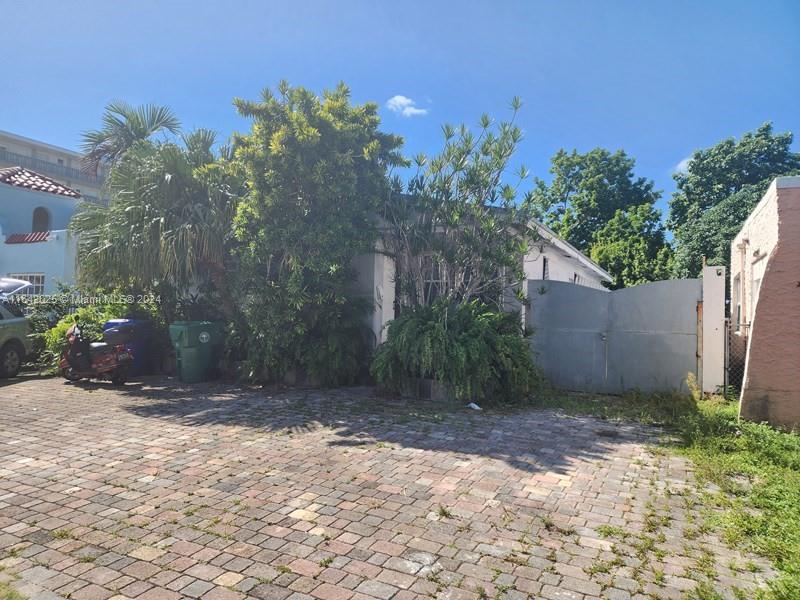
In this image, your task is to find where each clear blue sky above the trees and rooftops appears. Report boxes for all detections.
[0,0,800,218]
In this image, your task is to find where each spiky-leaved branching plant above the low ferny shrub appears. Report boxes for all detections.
[383,99,536,306]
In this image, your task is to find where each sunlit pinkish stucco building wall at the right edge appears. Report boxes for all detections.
[731,177,800,427]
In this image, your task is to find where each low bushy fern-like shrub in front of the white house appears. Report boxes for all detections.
[372,301,540,402]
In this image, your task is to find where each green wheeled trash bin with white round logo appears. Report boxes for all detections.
[169,321,222,383]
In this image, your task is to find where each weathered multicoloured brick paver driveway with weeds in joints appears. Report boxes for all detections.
[0,379,769,600]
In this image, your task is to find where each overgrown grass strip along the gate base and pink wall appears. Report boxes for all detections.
[536,393,800,600]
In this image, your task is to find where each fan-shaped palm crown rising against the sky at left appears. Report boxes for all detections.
[82,102,180,175]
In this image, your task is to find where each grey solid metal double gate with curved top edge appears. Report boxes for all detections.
[526,279,702,393]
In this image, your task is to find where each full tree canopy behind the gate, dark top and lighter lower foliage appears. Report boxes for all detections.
[534,148,670,287]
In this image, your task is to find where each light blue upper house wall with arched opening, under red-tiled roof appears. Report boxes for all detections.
[0,183,80,235]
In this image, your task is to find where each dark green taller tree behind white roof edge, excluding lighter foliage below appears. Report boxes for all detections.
[534,148,661,252]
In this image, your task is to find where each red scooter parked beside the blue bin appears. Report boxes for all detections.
[58,323,133,385]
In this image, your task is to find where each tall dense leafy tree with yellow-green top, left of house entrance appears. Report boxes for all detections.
[234,82,402,383]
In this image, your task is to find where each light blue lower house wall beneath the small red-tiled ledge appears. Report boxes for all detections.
[0,230,77,294]
